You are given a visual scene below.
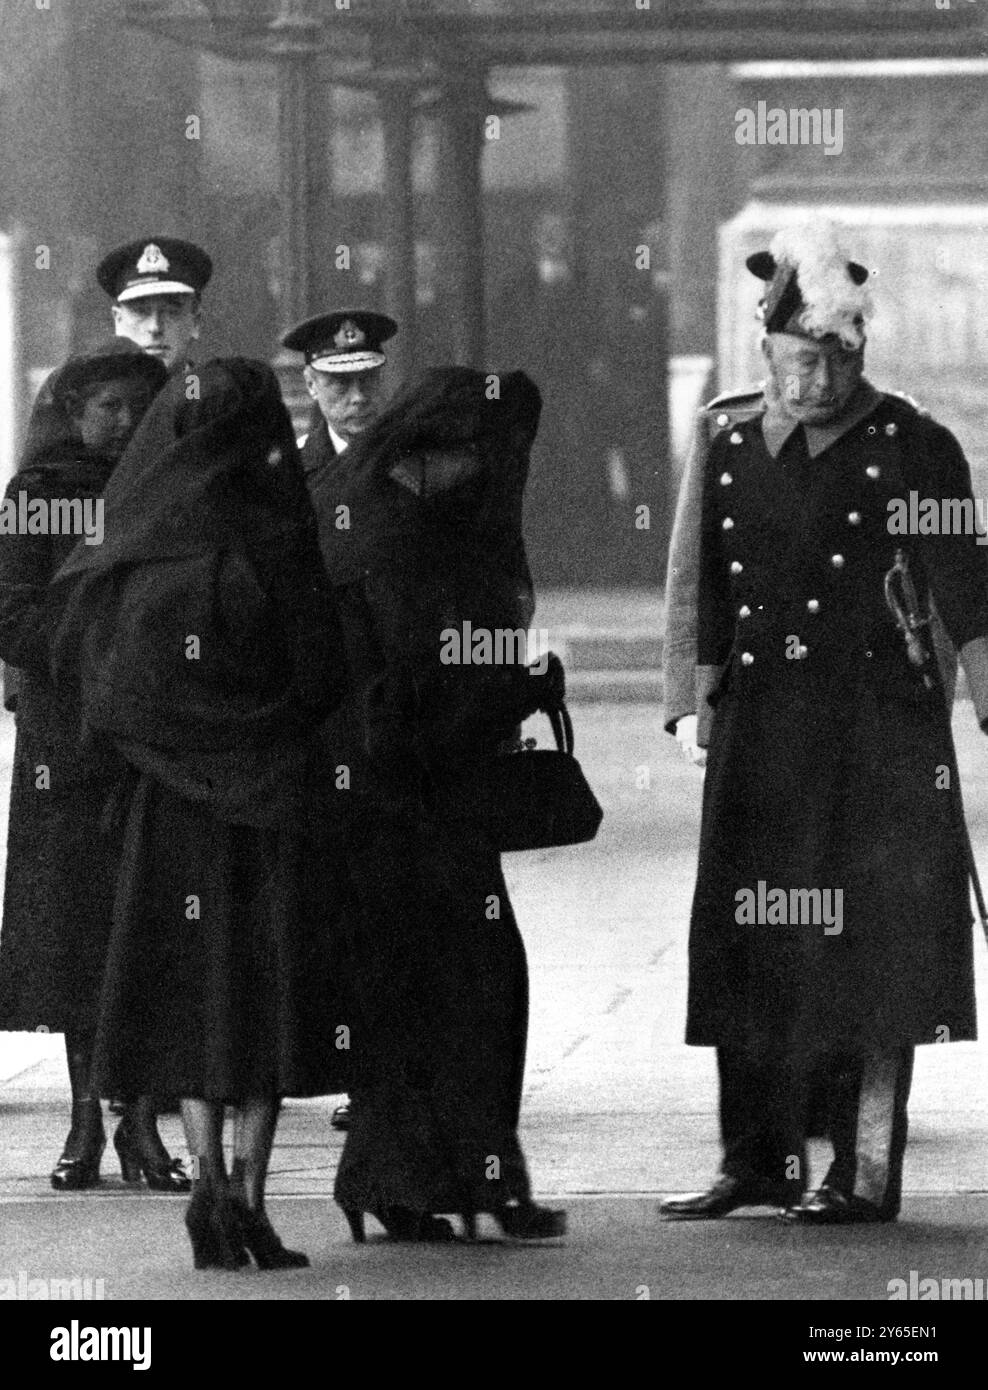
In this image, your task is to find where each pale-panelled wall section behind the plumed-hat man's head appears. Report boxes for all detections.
[720,60,988,496]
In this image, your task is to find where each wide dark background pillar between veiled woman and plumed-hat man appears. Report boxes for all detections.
[568,68,675,585]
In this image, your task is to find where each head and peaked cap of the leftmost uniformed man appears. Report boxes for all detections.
[96,236,213,371]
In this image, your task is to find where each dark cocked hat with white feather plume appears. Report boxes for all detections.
[745,220,874,352]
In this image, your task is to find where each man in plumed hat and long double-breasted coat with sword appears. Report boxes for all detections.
[663,221,988,1225]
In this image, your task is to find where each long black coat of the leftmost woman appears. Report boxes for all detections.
[0,449,117,1033]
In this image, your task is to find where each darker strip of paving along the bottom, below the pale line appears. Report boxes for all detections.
[0,1194,988,1301]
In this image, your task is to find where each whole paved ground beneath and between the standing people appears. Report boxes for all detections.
[0,703,988,1300]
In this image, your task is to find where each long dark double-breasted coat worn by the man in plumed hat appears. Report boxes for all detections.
[686,396,988,1051]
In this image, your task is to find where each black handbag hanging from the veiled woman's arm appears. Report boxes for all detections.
[475,705,603,851]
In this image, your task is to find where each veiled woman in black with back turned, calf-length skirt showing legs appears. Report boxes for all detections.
[54,359,349,1268]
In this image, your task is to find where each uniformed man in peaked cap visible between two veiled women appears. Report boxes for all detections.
[282,309,397,1130]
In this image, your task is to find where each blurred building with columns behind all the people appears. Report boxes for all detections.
[0,0,988,587]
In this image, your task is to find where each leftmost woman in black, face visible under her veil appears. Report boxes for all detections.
[0,338,189,1191]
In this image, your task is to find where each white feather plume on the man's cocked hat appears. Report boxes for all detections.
[768,218,874,349]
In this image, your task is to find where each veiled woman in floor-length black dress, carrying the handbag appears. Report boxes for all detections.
[315,368,564,1240]
